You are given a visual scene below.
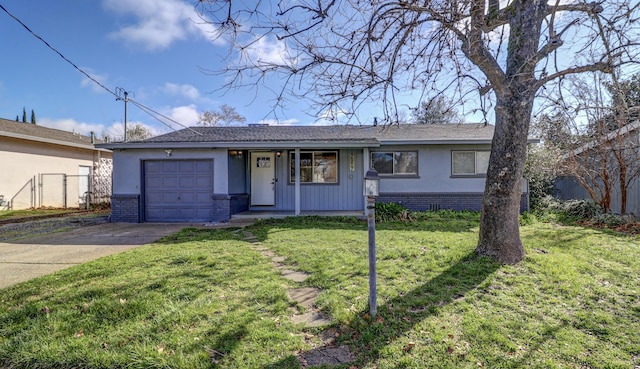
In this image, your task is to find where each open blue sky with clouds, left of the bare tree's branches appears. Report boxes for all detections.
[0,0,340,137]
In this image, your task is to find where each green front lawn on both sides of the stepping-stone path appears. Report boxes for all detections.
[0,212,640,369]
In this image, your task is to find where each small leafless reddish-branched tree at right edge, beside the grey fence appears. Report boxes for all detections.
[552,72,640,214]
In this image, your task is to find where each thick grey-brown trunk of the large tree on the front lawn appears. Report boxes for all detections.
[476,90,534,264]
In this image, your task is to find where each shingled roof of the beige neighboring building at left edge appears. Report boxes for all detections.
[0,118,107,150]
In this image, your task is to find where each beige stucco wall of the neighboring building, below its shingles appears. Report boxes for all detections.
[0,137,111,209]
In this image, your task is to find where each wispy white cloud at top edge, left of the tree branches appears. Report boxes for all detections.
[103,0,223,50]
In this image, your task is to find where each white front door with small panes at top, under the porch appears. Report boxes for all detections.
[250,152,276,205]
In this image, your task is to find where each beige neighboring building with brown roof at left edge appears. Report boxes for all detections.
[0,119,112,209]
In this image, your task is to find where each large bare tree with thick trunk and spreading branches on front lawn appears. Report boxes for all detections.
[198,0,640,263]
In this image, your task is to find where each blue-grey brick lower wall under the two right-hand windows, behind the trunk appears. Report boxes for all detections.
[376,192,529,212]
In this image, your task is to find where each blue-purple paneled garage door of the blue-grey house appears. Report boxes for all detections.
[144,160,213,222]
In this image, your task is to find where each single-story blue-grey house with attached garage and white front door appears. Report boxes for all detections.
[97,124,533,222]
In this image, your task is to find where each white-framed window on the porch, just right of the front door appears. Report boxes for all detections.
[289,151,338,183]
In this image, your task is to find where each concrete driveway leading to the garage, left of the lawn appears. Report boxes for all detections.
[0,223,189,289]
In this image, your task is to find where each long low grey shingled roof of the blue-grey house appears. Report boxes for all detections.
[100,124,504,148]
